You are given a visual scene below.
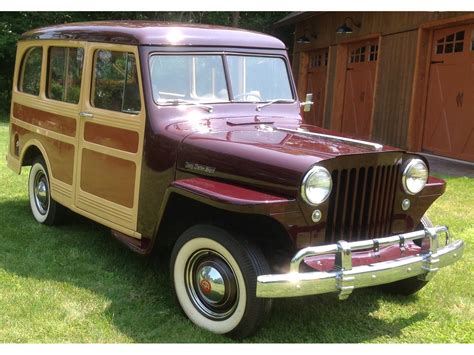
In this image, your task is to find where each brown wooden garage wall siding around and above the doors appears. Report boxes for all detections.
[294,12,472,149]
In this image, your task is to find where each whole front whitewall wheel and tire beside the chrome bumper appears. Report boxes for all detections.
[170,225,271,339]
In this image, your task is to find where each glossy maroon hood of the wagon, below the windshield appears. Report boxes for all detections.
[177,120,398,196]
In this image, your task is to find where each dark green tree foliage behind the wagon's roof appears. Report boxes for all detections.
[0,11,288,113]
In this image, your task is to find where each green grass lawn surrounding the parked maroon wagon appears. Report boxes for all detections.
[0,122,474,343]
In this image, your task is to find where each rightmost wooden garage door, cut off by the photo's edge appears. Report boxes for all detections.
[423,24,474,162]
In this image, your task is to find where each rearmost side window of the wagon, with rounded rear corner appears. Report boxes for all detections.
[18,47,43,95]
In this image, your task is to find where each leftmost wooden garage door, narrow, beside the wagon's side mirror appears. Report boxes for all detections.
[304,48,329,127]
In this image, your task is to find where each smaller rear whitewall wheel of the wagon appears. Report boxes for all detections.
[28,157,62,225]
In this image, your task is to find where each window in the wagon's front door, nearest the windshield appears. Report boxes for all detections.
[91,49,141,114]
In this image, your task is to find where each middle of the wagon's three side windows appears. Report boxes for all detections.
[46,47,84,104]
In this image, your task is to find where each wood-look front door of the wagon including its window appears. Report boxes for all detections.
[75,43,146,237]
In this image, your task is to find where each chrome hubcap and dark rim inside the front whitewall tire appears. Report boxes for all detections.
[185,250,239,320]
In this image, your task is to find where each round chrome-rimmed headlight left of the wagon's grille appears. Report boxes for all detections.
[301,166,332,205]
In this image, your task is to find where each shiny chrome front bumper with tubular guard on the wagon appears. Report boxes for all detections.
[257,226,464,300]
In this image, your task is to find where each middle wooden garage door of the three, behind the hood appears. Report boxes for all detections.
[342,39,378,139]
